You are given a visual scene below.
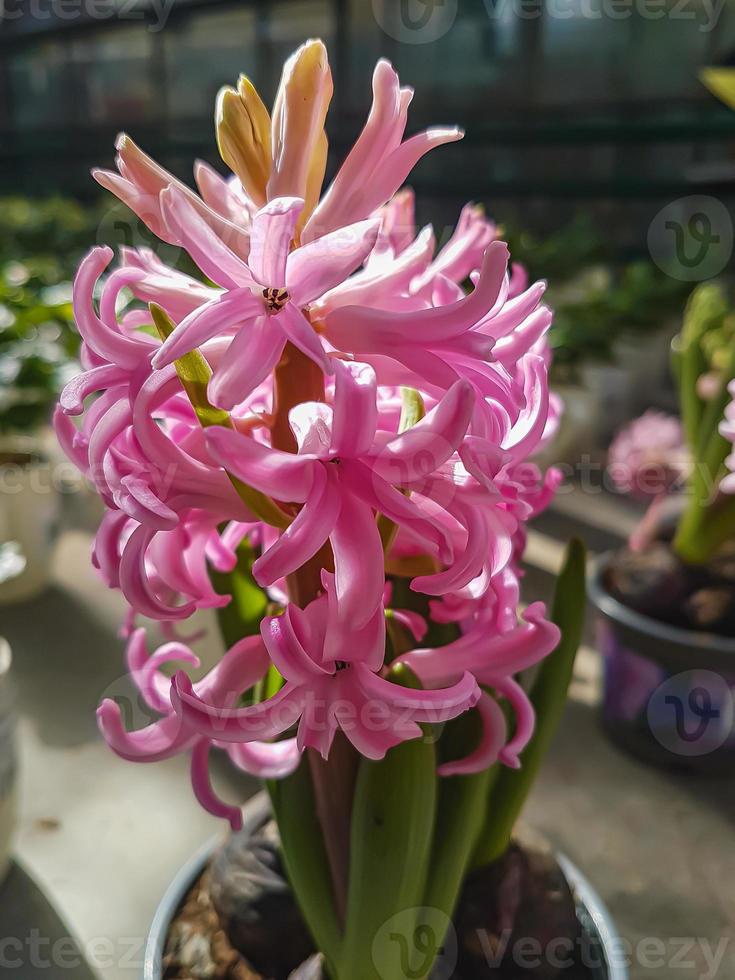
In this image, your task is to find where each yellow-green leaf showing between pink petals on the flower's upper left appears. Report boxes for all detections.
[149,303,290,528]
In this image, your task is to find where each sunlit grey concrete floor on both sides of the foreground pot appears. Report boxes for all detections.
[0,499,735,980]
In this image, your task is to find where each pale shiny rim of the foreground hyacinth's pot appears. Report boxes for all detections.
[142,792,629,980]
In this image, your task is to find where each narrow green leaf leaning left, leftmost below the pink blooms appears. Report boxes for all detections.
[267,754,342,976]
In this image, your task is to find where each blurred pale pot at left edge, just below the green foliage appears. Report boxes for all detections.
[0,438,60,603]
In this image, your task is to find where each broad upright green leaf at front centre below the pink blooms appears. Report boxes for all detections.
[337,668,437,980]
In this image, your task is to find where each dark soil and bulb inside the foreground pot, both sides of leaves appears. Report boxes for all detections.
[164,821,605,980]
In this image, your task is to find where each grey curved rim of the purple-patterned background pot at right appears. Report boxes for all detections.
[587,551,735,657]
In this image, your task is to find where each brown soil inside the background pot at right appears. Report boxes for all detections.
[605,542,735,638]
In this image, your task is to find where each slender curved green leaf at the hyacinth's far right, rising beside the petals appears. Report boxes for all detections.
[473,538,585,867]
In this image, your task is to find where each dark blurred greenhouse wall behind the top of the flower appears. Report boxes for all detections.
[0,0,735,256]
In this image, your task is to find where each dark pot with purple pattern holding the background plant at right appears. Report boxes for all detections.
[588,554,735,773]
